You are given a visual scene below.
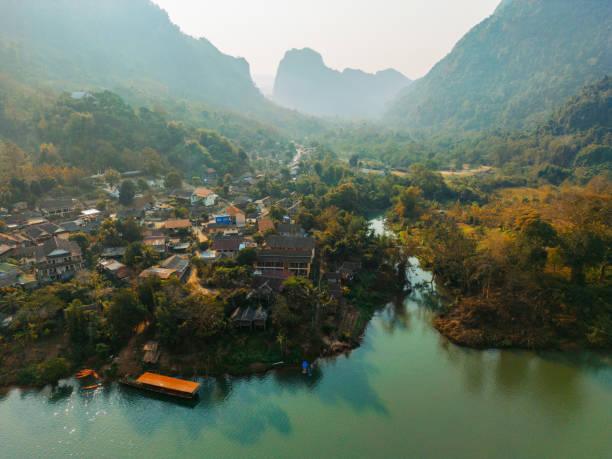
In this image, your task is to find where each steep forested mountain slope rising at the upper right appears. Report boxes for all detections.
[388,0,612,130]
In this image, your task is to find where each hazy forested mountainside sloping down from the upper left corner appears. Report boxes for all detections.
[0,0,320,131]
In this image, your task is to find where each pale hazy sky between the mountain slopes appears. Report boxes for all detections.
[153,0,500,86]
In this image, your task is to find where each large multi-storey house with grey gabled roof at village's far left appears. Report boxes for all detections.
[34,237,85,282]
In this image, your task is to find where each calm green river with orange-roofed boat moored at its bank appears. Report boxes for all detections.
[0,220,612,458]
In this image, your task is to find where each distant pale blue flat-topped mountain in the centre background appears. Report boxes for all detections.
[273,48,410,118]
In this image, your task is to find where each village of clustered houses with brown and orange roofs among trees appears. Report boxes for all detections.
[0,145,382,380]
